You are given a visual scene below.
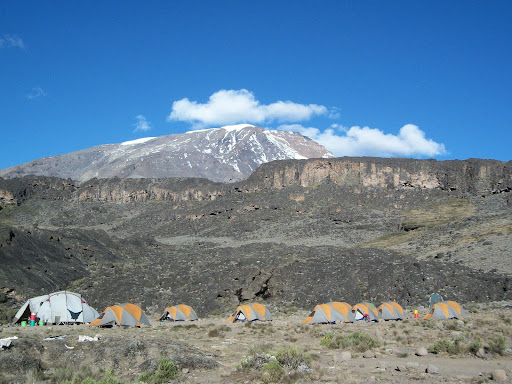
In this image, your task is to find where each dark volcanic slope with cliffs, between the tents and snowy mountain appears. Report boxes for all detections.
[0,158,512,321]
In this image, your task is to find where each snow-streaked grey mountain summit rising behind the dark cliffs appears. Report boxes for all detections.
[0,124,334,182]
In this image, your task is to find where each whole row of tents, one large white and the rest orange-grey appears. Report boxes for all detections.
[13,291,466,327]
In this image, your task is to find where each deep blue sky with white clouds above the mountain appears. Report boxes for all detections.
[0,0,512,168]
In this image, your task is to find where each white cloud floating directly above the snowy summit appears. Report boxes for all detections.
[168,89,328,129]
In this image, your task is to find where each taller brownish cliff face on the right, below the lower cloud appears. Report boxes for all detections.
[249,158,512,193]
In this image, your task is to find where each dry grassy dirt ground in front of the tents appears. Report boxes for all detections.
[0,302,512,383]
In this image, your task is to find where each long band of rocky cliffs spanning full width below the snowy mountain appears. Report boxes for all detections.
[0,158,512,205]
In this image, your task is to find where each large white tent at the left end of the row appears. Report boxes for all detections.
[13,291,98,324]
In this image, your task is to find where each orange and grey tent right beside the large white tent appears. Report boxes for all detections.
[89,303,151,327]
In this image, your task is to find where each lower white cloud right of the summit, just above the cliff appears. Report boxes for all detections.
[278,124,446,157]
